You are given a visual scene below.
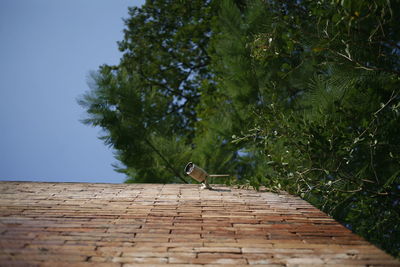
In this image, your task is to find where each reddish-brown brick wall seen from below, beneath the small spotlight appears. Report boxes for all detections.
[0,182,400,267]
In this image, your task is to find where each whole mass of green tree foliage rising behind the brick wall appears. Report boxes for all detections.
[80,0,400,256]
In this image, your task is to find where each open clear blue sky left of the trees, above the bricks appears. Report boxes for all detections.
[0,0,144,183]
